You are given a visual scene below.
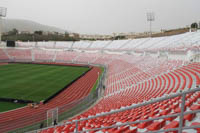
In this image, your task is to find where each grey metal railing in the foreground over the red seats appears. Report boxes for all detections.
[34,87,200,133]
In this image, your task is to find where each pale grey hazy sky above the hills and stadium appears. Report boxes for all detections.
[0,0,200,34]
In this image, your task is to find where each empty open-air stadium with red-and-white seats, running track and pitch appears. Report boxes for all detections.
[0,0,200,133]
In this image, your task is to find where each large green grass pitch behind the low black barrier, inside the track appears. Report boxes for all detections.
[0,64,89,112]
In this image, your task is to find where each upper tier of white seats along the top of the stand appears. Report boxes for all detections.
[14,30,200,51]
